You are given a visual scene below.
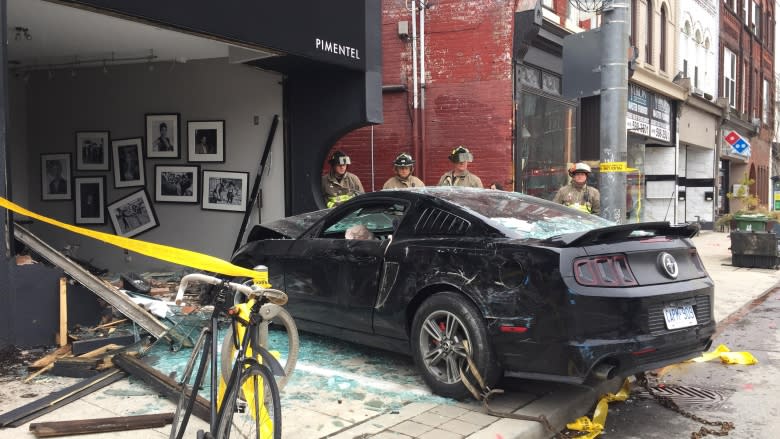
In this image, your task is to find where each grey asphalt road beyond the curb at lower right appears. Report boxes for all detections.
[603,290,780,439]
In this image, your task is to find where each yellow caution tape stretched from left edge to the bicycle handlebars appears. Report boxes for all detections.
[0,197,271,288]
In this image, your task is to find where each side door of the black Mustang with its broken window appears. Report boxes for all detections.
[286,200,406,332]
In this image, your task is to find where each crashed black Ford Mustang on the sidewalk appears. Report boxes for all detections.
[233,187,715,398]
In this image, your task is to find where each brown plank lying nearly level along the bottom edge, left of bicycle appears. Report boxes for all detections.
[30,413,173,437]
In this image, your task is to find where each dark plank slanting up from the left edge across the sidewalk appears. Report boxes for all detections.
[0,369,127,427]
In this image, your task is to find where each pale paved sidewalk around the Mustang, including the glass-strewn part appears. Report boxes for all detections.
[0,232,778,439]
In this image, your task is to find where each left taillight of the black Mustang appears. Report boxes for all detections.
[574,255,637,287]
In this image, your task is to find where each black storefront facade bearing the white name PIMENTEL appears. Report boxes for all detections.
[0,0,382,346]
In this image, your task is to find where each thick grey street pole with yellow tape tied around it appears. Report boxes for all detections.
[599,0,631,224]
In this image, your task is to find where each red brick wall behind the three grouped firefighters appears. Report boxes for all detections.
[323,0,515,190]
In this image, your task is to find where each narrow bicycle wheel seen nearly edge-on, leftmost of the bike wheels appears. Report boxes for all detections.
[169,328,211,439]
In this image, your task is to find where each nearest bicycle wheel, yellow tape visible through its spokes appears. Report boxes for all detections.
[217,360,282,439]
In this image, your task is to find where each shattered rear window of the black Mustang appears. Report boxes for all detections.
[412,187,615,239]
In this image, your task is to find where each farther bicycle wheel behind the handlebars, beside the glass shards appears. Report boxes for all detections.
[220,307,299,390]
